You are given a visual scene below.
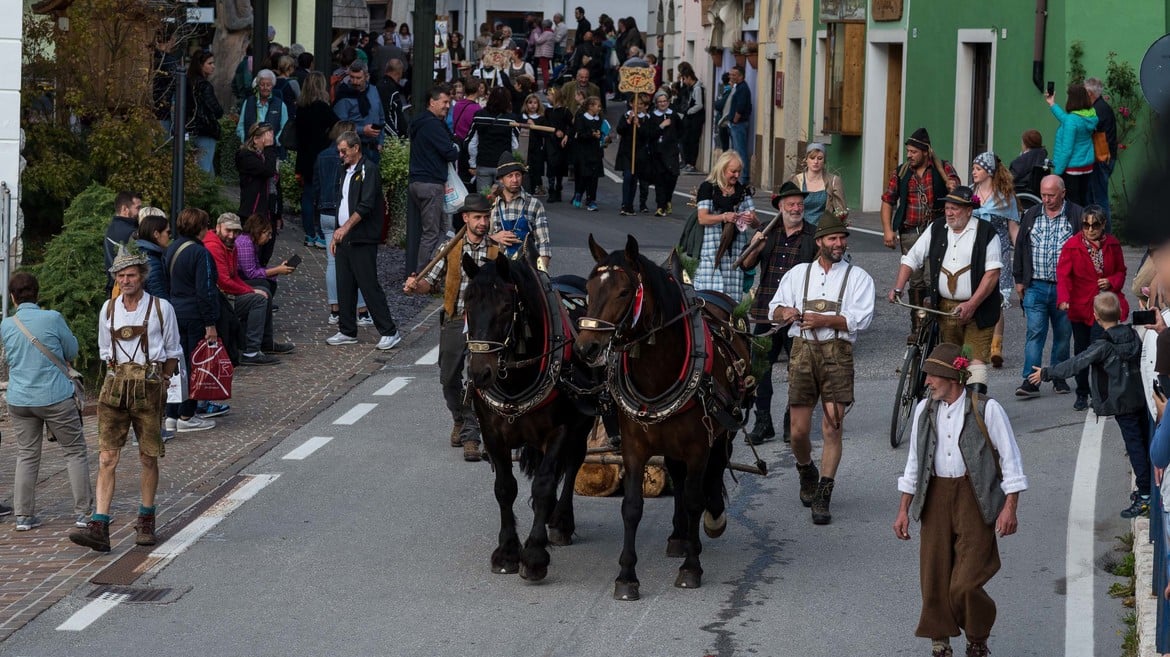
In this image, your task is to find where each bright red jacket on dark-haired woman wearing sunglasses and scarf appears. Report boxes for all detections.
[1057,233,1129,324]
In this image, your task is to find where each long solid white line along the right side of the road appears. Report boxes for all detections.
[1065,409,1104,657]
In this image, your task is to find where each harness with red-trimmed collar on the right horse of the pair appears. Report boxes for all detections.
[578,265,755,444]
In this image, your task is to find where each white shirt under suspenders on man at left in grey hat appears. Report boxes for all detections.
[97,292,183,365]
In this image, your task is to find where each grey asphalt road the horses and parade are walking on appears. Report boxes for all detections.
[0,171,1129,657]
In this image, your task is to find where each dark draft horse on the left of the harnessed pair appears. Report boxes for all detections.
[462,248,593,581]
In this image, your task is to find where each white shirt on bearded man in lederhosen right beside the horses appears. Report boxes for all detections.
[768,258,874,343]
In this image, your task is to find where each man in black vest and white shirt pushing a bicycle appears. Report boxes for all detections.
[887,182,1004,394]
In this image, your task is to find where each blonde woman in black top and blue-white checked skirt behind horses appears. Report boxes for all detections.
[695,151,758,303]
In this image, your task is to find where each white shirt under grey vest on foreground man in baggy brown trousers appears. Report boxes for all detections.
[897,390,1027,495]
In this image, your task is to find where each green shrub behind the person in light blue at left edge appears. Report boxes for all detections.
[34,182,115,381]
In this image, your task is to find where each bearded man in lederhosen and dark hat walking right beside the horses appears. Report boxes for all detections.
[768,216,874,525]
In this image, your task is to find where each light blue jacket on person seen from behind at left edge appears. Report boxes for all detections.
[0,303,77,407]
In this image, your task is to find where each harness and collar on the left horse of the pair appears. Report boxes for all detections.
[467,263,573,416]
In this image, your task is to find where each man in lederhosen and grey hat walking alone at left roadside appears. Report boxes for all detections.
[69,248,183,552]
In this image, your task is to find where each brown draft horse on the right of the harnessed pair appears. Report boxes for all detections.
[576,235,755,600]
